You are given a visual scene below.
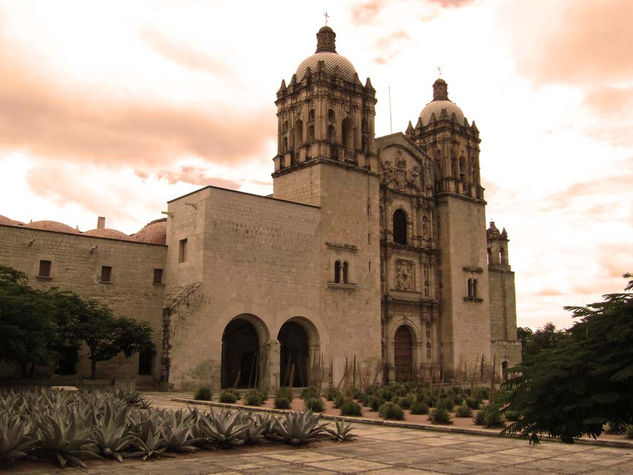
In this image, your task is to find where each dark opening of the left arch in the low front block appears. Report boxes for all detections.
[221,318,260,388]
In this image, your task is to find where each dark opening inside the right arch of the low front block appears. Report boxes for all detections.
[277,321,310,387]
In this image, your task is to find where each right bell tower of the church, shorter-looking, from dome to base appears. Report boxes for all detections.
[406,78,492,378]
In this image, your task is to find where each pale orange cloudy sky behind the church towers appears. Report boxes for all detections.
[0,0,633,328]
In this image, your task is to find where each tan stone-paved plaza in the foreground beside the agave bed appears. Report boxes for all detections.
[14,392,633,475]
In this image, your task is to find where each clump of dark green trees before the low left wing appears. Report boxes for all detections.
[0,266,154,378]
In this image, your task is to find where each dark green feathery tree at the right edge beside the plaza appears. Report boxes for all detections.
[505,274,633,443]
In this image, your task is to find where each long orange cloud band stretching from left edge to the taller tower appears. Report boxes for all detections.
[0,28,275,167]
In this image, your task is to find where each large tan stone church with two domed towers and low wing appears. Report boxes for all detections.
[0,26,521,389]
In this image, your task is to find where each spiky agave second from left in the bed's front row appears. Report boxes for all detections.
[36,413,101,468]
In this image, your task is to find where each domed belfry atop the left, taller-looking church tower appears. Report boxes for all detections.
[272,26,378,205]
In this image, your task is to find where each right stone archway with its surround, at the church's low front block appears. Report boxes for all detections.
[277,317,320,387]
